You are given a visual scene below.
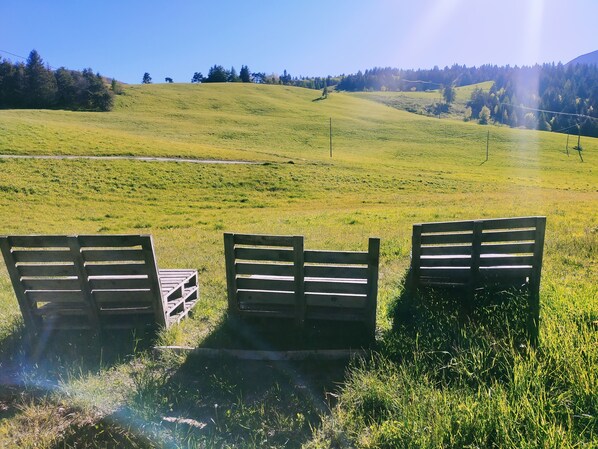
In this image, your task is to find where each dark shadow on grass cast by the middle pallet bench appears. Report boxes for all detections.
[43,319,365,448]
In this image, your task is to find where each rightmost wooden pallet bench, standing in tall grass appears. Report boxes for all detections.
[410,217,546,342]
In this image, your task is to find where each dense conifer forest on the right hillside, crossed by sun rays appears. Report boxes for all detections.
[336,64,598,137]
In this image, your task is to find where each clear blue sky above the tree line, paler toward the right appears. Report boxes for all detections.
[0,0,598,83]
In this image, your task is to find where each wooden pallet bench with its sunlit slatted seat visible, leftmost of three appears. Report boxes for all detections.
[0,235,199,334]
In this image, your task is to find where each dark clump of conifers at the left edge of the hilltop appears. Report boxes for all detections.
[0,50,118,111]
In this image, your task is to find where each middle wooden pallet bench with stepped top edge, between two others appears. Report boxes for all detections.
[224,233,380,336]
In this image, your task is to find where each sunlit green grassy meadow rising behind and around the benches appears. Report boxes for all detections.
[0,84,598,448]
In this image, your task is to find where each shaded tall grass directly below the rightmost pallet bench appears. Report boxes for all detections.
[382,268,529,387]
